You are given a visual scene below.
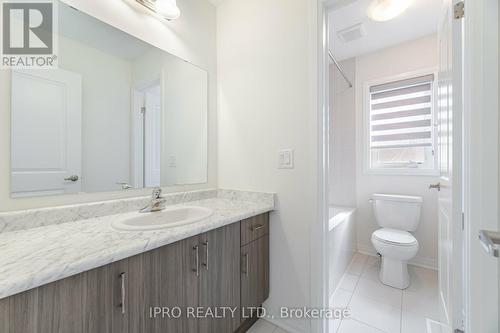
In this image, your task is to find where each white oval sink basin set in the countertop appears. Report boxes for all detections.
[111,206,214,231]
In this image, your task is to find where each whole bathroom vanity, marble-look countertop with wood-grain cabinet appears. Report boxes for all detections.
[0,189,272,333]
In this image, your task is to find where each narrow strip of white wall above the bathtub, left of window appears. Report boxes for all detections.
[328,58,356,207]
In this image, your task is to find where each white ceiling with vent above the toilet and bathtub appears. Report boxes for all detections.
[329,0,442,60]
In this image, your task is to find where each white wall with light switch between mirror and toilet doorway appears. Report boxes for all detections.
[217,0,318,332]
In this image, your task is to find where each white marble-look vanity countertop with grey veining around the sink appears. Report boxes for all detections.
[0,197,274,299]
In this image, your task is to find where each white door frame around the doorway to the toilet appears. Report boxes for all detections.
[316,0,500,332]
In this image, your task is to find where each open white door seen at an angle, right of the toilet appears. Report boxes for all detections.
[436,0,463,331]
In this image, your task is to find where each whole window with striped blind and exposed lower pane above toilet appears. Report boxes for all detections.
[368,74,436,174]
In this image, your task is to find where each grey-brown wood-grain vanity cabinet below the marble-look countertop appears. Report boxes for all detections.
[0,214,269,333]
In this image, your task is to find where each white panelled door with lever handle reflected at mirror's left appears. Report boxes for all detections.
[11,69,82,197]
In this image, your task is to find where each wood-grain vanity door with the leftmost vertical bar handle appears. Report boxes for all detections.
[83,260,128,333]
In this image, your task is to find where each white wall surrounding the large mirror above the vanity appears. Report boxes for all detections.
[0,0,217,211]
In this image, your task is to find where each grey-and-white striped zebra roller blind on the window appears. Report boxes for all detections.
[370,74,434,149]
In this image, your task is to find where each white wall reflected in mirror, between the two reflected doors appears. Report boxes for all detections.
[59,37,132,192]
